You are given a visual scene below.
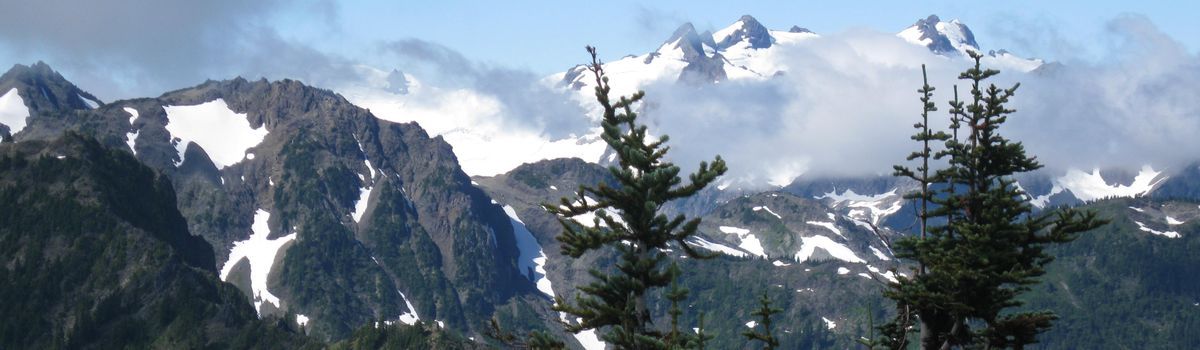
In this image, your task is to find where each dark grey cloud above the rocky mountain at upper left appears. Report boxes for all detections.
[0,0,349,99]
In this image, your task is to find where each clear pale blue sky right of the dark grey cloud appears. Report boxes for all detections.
[278,0,1200,73]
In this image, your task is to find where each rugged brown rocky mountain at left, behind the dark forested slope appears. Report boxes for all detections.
[2,66,553,340]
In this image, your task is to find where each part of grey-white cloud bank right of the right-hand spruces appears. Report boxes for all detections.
[1013,16,1200,169]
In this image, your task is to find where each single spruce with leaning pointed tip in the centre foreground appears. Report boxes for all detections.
[544,47,726,349]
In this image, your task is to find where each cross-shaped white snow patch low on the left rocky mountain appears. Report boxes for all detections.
[221,209,296,316]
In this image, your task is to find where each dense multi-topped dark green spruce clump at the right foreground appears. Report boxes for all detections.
[881,52,1105,349]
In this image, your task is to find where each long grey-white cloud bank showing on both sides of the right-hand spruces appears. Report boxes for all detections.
[604,16,1200,183]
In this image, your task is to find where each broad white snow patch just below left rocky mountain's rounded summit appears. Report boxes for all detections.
[163,98,268,169]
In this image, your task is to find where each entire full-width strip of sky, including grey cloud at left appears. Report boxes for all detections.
[0,0,1200,99]
